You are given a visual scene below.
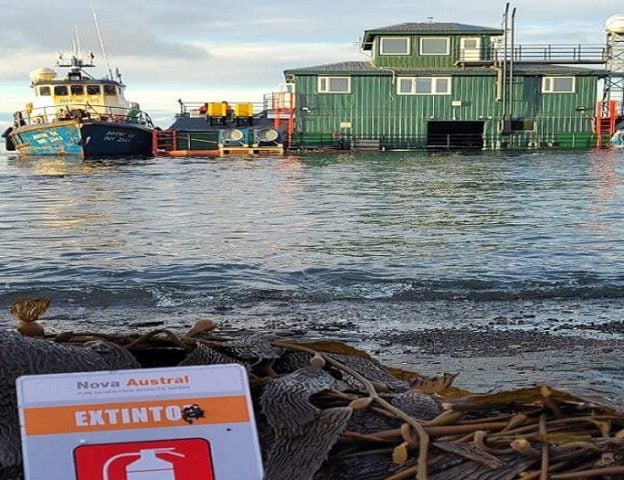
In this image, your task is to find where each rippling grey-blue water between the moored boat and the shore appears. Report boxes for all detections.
[0,151,624,398]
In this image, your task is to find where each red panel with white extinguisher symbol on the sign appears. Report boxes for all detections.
[74,438,214,480]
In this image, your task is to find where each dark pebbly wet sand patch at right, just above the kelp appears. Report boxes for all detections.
[372,329,624,409]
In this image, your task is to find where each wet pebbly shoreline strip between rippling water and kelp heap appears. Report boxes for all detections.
[0,299,624,410]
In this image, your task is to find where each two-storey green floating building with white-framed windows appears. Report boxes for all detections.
[284,22,607,149]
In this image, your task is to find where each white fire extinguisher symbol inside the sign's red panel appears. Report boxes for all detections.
[102,448,184,480]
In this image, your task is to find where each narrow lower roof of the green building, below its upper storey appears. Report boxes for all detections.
[284,62,607,77]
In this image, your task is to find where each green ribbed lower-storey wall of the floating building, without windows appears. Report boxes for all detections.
[295,72,597,148]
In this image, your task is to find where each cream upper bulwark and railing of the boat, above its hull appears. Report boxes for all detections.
[14,103,154,127]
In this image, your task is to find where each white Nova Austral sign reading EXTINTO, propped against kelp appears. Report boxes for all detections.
[17,365,263,480]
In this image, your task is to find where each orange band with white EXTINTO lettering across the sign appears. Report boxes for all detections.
[24,396,250,435]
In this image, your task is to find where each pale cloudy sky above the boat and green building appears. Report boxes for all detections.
[0,0,624,127]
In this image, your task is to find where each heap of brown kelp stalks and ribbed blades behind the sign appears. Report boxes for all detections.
[0,298,624,480]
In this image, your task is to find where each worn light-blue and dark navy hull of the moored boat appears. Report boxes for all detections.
[9,120,152,158]
